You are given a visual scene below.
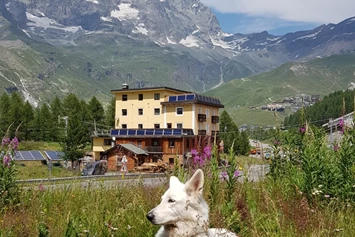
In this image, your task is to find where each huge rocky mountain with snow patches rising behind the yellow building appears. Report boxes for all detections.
[0,0,355,104]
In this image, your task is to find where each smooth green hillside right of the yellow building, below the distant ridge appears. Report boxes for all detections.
[205,55,355,126]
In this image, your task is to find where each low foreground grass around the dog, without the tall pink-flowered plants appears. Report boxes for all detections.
[0,173,355,237]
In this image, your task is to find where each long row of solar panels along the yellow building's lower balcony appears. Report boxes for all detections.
[111,128,194,136]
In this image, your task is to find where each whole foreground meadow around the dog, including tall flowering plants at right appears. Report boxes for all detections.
[0,126,355,237]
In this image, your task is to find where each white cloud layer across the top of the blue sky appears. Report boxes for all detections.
[201,0,355,24]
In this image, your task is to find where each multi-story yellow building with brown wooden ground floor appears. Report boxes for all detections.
[93,84,224,170]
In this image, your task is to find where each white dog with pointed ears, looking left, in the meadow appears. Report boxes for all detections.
[147,169,237,237]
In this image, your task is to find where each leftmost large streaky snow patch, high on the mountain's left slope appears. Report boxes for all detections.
[26,12,81,33]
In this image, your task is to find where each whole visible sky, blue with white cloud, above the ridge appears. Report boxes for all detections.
[200,0,355,35]
